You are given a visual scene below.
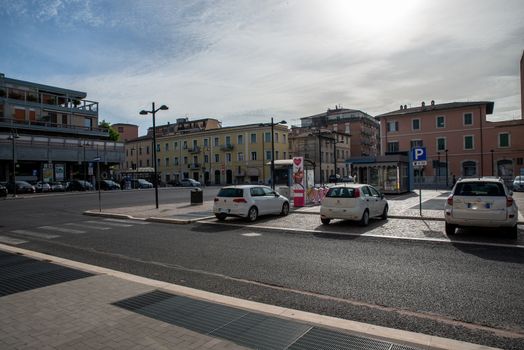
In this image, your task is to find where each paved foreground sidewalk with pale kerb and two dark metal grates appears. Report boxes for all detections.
[0,244,500,350]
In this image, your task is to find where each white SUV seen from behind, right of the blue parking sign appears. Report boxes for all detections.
[444,177,518,238]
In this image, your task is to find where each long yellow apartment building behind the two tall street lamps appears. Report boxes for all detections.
[126,118,289,185]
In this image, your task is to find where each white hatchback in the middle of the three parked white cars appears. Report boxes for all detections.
[320,183,389,226]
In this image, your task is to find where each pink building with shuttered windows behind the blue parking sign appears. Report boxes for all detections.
[377,101,524,185]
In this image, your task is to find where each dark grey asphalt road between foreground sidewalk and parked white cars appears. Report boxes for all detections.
[0,189,524,349]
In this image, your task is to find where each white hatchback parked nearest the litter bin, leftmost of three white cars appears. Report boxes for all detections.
[213,185,289,221]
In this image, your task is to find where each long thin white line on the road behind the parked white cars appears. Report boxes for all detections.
[200,221,524,249]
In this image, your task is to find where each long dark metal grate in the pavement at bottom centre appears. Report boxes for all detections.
[113,290,422,350]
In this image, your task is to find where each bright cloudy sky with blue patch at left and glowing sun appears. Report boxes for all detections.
[0,0,524,135]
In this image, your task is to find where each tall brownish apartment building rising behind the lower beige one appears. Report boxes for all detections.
[300,106,380,157]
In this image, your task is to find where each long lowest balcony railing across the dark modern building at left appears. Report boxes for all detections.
[0,118,109,136]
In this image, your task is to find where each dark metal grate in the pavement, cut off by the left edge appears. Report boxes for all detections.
[0,253,93,297]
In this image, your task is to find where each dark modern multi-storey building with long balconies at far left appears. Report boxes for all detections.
[0,73,124,181]
